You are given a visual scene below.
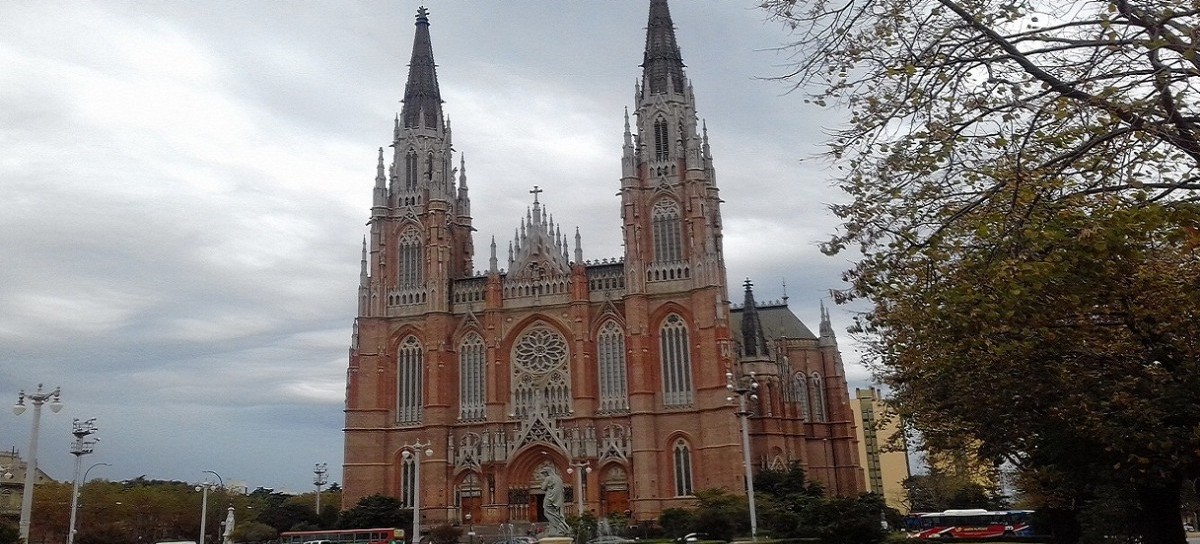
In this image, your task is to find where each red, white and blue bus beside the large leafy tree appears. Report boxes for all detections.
[905,509,1033,538]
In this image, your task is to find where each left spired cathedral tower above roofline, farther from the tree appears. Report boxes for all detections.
[367,7,474,316]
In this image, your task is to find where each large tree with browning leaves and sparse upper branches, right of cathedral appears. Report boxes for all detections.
[763,0,1200,544]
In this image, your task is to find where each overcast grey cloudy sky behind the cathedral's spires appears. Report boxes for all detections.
[0,0,868,491]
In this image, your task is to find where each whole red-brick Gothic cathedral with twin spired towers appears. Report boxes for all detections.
[342,0,863,530]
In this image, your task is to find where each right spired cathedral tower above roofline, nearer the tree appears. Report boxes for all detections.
[620,0,726,299]
